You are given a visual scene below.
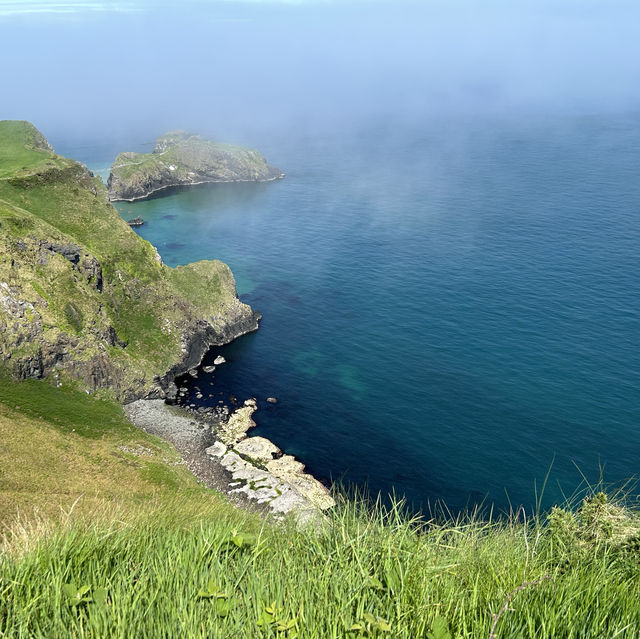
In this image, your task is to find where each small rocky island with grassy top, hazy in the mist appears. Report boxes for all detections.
[107,131,284,202]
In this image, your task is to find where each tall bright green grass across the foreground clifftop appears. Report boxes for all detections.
[0,496,640,639]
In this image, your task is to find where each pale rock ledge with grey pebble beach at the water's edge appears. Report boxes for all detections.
[125,399,335,522]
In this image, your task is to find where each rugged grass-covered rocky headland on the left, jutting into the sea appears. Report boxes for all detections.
[0,121,259,400]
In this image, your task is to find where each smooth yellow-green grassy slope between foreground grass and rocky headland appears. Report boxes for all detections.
[0,376,231,528]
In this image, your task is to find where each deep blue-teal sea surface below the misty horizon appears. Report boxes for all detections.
[60,113,640,511]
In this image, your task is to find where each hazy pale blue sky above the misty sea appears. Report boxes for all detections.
[0,0,640,145]
